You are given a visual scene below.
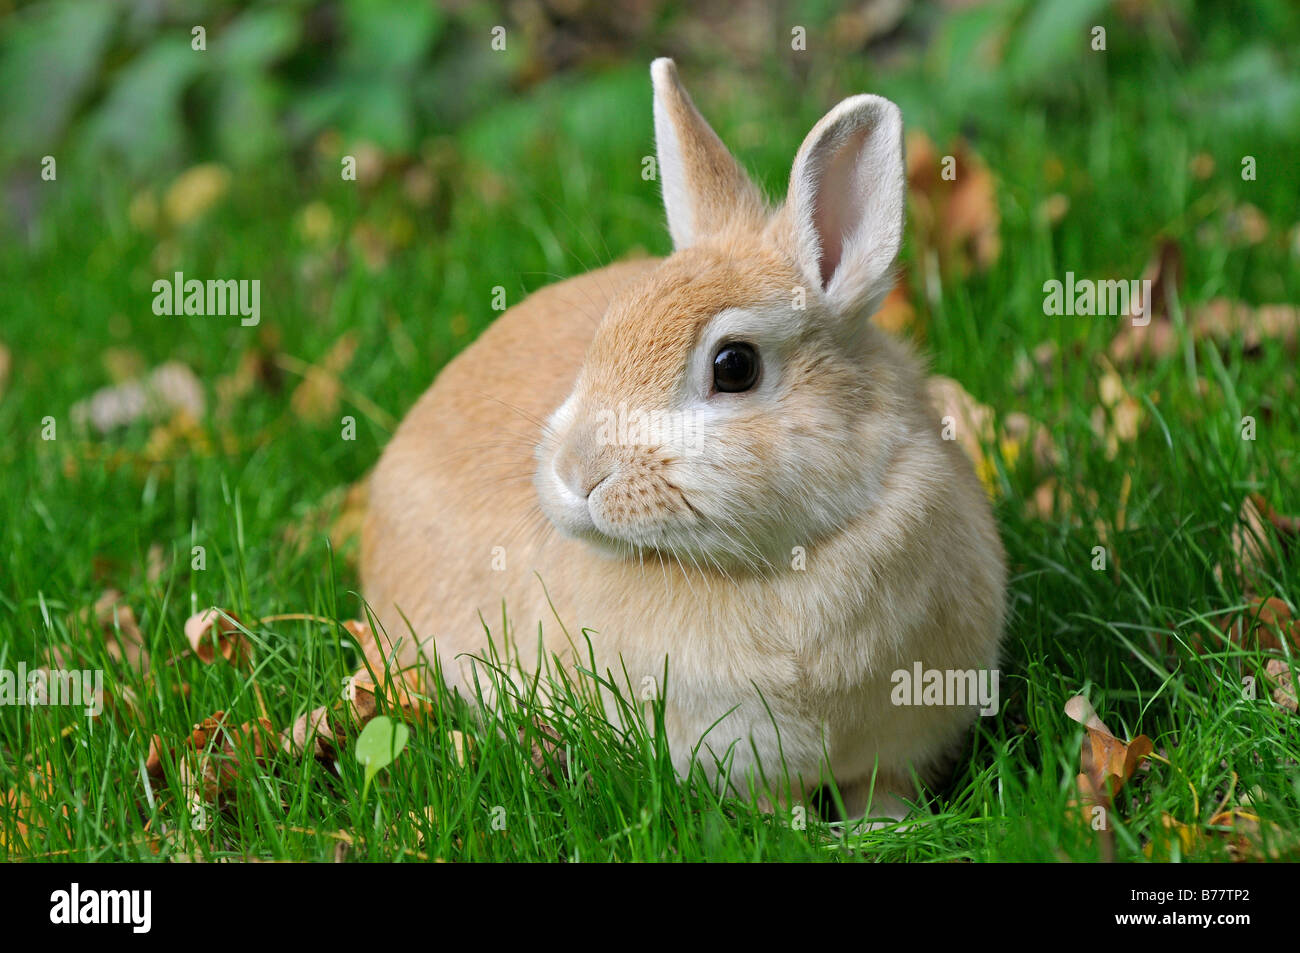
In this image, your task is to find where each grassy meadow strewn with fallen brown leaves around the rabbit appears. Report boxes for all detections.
[0,1,1300,862]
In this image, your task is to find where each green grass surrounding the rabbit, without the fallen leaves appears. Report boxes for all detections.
[0,1,1300,861]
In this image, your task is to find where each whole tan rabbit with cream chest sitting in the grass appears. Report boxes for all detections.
[361,59,1006,818]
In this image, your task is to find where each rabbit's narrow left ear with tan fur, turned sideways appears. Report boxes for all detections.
[650,57,764,250]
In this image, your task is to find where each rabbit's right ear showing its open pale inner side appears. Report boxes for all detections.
[787,96,907,317]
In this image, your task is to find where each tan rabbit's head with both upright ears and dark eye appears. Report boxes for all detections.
[534,59,910,567]
